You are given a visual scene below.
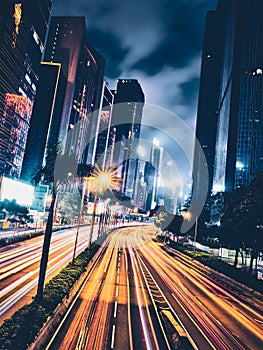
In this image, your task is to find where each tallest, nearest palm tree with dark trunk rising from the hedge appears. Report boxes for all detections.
[31,144,77,301]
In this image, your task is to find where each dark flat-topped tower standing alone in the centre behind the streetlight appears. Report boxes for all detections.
[112,79,144,199]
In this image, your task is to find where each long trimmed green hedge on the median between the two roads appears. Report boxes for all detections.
[0,238,102,350]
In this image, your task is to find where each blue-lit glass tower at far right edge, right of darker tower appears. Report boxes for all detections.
[213,0,263,192]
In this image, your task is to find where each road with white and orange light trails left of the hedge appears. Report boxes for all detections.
[0,226,97,324]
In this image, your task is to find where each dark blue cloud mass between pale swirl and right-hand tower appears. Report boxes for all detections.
[133,0,216,75]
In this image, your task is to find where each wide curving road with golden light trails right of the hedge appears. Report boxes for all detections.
[47,226,263,350]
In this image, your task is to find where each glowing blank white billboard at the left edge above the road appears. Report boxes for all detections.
[0,176,34,206]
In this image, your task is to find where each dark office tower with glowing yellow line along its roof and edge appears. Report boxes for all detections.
[21,62,66,182]
